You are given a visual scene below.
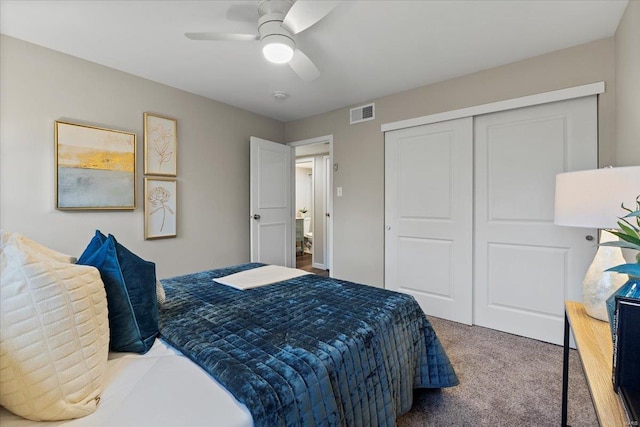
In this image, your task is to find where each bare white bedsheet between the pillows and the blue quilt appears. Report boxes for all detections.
[0,339,253,427]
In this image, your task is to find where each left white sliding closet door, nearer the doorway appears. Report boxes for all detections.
[385,117,473,324]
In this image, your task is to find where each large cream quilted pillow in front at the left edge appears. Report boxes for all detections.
[0,233,109,421]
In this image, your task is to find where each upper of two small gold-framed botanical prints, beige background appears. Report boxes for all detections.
[144,113,178,176]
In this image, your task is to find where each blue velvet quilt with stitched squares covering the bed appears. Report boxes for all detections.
[159,263,458,427]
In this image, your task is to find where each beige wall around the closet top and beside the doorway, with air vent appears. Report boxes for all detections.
[286,38,615,286]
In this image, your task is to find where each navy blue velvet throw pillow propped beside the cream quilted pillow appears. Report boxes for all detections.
[77,230,158,354]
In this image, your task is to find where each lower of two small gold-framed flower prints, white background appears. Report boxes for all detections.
[144,177,178,240]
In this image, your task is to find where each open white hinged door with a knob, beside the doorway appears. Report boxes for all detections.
[250,136,295,267]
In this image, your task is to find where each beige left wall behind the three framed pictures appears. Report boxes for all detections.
[0,36,284,277]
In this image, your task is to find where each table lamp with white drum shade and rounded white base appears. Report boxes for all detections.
[554,166,640,321]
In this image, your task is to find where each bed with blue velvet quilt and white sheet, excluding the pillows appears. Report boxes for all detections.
[0,236,458,427]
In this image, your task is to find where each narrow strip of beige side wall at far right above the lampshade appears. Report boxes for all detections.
[615,0,640,166]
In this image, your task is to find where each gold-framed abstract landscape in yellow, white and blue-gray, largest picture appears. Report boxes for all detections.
[54,120,136,210]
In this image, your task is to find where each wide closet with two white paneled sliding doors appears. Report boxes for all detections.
[385,95,598,344]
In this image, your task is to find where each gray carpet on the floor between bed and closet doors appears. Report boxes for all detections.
[398,317,598,427]
